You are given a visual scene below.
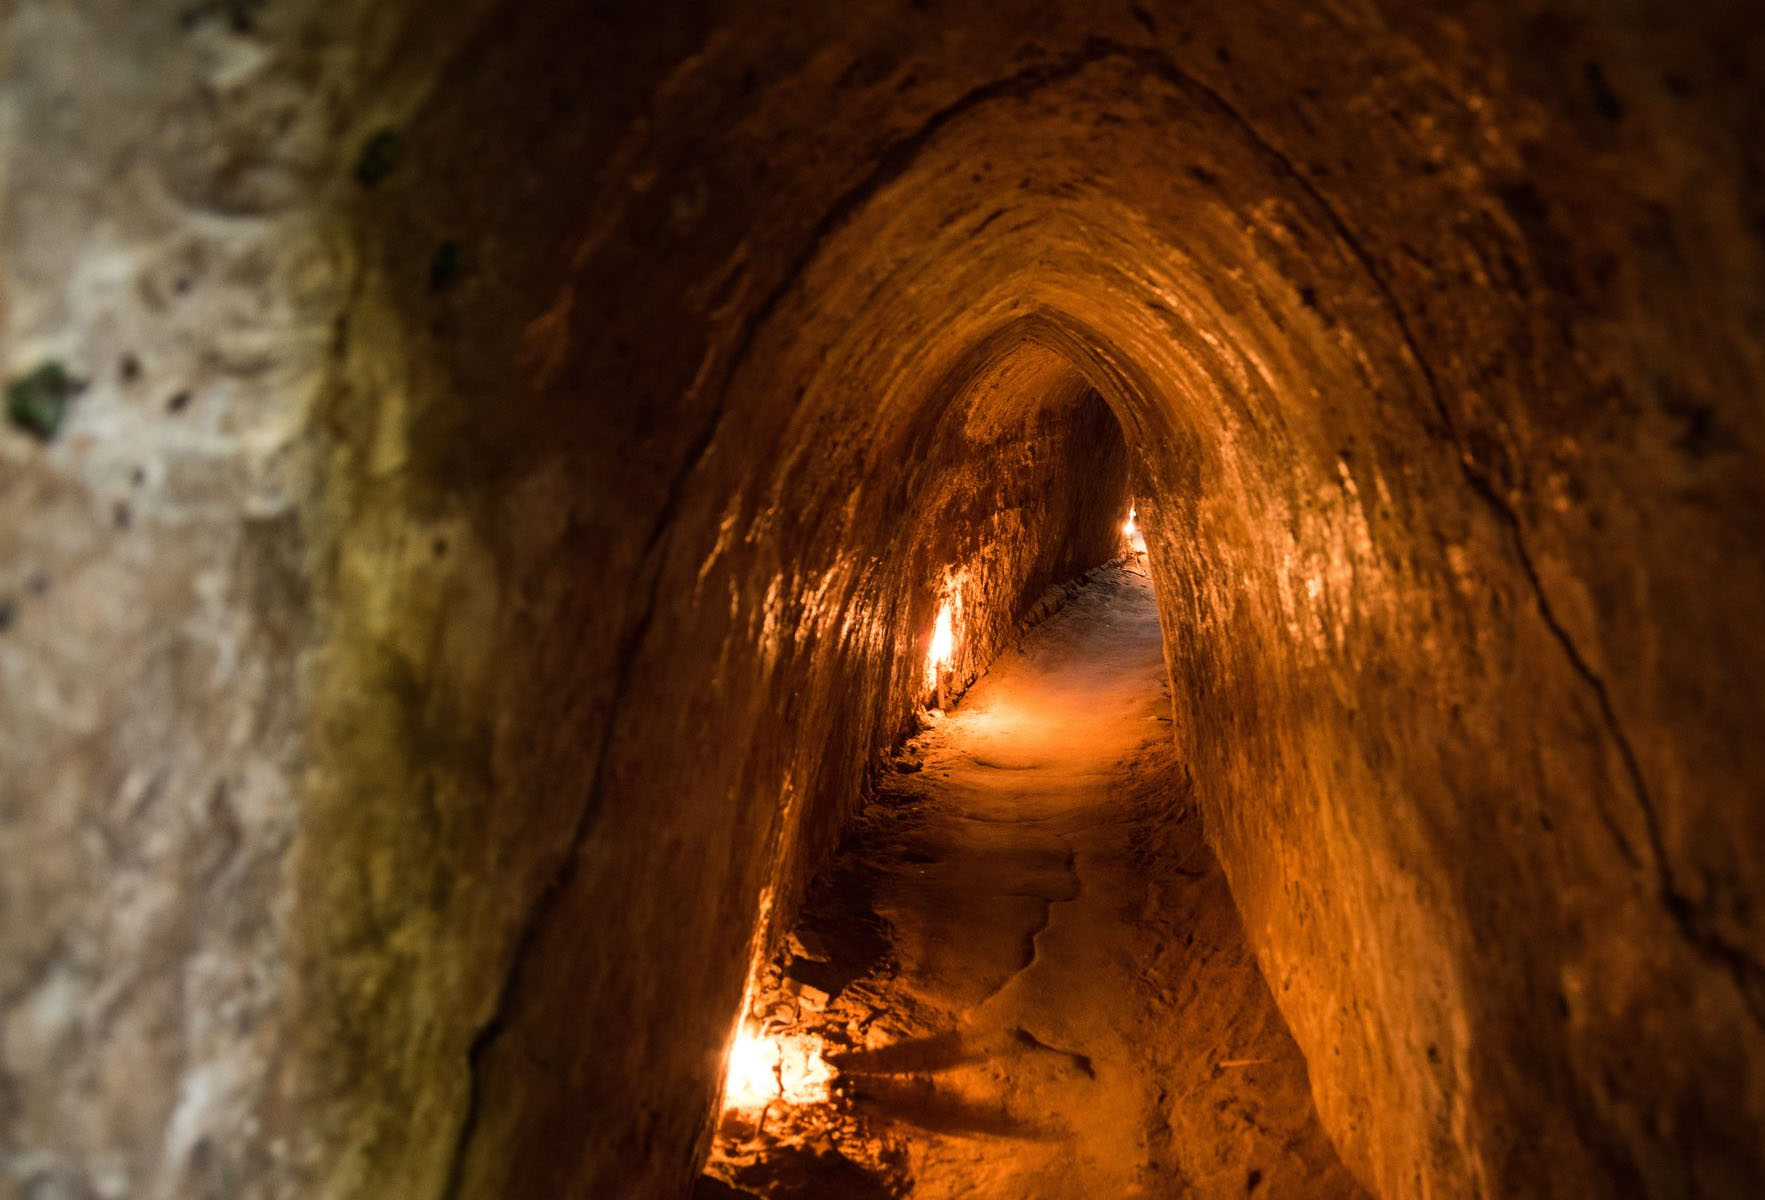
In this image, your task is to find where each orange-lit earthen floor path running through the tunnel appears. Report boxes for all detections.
[699,566,1364,1200]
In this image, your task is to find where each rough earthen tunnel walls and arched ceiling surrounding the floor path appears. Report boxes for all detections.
[0,0,1765,1196]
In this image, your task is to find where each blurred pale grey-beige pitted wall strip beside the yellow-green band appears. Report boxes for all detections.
[0,0,353,1200]
